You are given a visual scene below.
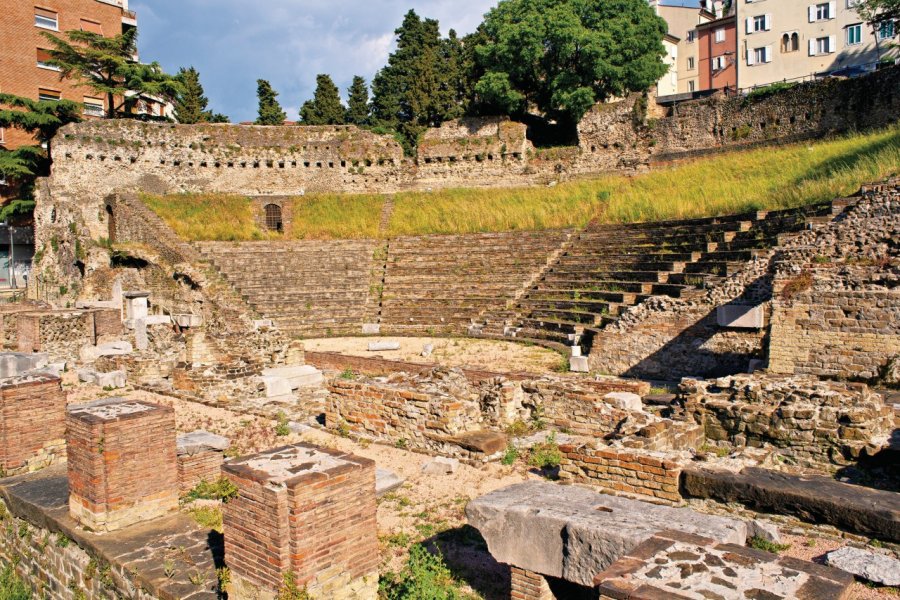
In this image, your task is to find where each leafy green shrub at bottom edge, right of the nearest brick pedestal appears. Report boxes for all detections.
[379,544,466,600]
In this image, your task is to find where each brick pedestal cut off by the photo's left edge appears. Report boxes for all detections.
[0,375,66,475]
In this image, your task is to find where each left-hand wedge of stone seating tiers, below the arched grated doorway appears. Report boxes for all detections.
[197,240,380,337]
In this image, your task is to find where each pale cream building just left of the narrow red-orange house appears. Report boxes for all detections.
[650,0,714,96]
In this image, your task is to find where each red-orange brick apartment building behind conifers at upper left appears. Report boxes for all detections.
[0,0,137,149]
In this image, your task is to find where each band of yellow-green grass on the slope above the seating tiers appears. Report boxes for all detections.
[145,126,900,240]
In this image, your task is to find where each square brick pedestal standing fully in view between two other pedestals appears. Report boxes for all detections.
[66,398,178,531]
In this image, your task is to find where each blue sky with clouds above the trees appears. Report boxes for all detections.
[130,0,496,122]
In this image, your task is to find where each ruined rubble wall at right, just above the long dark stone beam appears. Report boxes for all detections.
[679,375,894,464]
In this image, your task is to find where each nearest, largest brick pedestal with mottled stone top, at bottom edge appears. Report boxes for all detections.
[222,444,378,600]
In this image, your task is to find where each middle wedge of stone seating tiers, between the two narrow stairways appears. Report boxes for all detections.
[381,230,571,333]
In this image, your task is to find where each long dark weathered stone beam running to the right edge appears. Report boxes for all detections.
[681,467,900,542]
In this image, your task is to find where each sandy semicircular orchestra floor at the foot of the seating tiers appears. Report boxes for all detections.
[303,337,568,373]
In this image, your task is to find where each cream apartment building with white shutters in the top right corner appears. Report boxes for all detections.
[736,0,898,88]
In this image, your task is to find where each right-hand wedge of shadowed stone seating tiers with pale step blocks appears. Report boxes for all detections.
[473,198,853,355]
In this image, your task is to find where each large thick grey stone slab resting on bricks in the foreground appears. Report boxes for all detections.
[466,481,747,586]
